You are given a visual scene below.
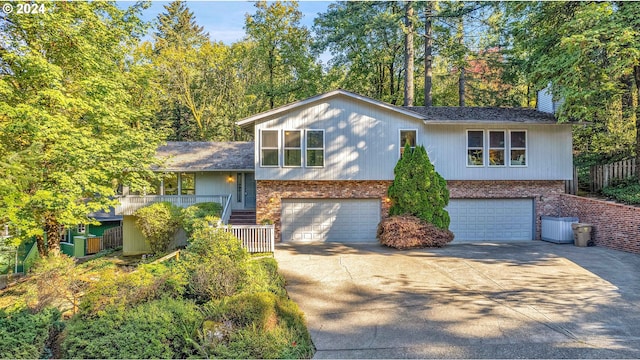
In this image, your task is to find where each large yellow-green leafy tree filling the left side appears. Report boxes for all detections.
[0,2,159,256]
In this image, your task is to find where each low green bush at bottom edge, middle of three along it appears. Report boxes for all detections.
[62,298,203,359]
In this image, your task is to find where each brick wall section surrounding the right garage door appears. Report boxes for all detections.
[447,180,564,240]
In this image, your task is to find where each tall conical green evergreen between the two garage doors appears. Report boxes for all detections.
[388,144,450,229]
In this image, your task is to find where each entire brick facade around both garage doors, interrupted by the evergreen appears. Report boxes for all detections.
[256,180,564,241]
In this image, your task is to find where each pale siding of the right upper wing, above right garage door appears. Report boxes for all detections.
[418,124,573,180]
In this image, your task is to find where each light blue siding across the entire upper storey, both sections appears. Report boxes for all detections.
[255,97,573,180]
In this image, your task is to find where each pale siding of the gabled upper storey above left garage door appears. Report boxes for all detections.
[255,98,423,180]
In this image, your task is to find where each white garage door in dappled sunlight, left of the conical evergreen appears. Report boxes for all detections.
[281,199,380,242]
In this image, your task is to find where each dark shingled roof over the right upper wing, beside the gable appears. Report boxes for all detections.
[404,106,557,124]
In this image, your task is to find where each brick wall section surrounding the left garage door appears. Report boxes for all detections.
[256,180,391,241]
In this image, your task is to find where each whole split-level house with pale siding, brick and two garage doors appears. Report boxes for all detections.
[115,90,573,255]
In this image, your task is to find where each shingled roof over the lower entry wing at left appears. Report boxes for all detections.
[156,141,255,171]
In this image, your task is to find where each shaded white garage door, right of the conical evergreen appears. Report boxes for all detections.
[447,199,534,241]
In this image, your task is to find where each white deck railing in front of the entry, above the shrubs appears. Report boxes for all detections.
[116,195,231,215]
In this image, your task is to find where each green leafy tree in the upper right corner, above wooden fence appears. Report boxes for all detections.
[508,2,640,175]
